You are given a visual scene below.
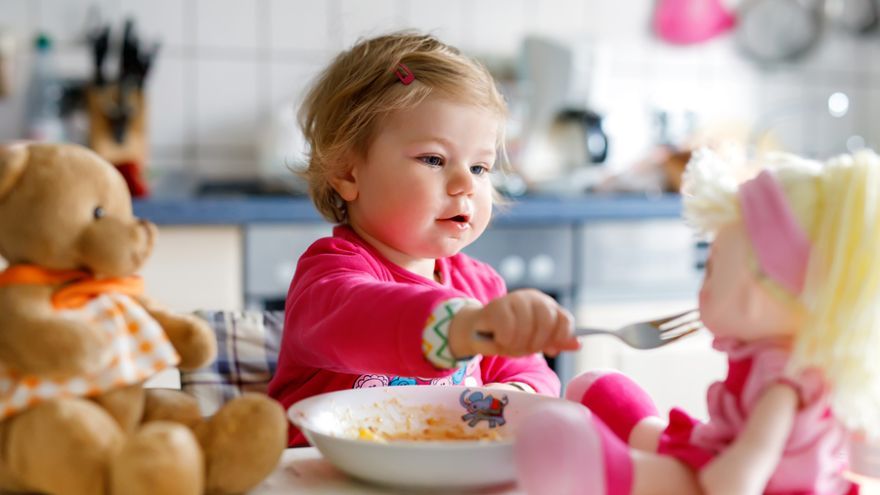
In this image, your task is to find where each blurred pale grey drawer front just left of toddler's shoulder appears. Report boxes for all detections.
[245,224,333,298]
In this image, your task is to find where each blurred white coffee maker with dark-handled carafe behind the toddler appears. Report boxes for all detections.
[514,36,609,194]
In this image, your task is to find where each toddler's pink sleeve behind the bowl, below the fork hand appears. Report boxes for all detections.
[480,354,561,397]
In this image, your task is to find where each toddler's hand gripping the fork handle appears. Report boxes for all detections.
[449,289,580,357]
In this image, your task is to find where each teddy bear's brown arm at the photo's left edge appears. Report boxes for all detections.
[0,287,112,377]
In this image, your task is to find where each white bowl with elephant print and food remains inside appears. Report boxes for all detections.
[287,385,562,488]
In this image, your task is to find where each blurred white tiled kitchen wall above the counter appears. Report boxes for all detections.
[0,0,880,174]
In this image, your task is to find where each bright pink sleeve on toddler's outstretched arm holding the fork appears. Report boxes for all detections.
[282,238,467,378]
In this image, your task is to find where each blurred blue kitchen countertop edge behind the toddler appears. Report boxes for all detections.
[134,194,681,225]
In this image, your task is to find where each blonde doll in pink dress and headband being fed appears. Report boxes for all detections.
[516,151,880,495]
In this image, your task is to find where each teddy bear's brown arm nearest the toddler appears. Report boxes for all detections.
[146,306,217,370]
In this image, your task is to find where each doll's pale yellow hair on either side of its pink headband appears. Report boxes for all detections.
[683,150,880,435]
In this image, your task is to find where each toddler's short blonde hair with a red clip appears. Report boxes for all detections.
[299,31,507,222]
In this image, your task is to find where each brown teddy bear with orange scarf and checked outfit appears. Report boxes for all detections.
[0,144,287,495]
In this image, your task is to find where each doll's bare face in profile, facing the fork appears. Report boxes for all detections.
[700,223,800,340]
